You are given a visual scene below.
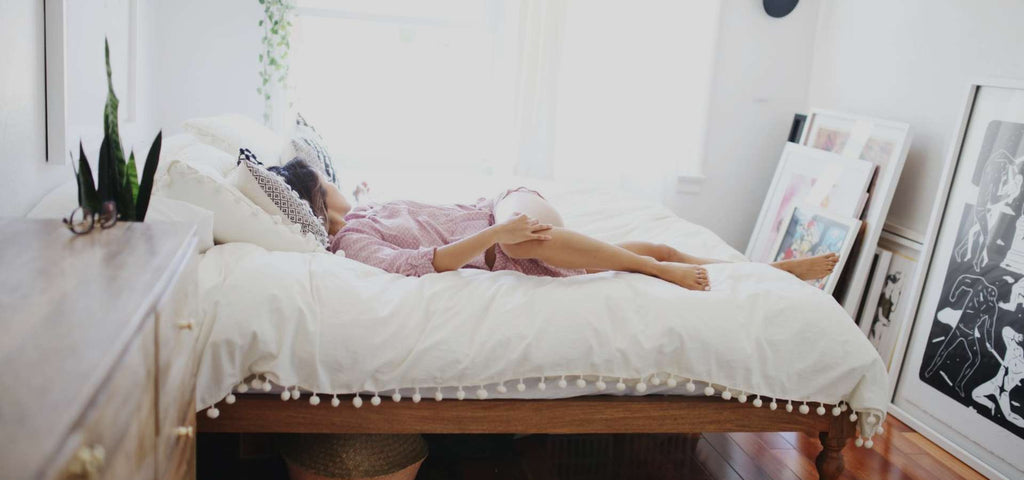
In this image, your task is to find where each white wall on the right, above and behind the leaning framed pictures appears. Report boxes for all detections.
[808,0,1024,233]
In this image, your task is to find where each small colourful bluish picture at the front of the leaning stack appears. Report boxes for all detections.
[771,201,860,293]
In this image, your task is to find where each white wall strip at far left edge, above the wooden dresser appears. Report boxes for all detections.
[0,0,66,216]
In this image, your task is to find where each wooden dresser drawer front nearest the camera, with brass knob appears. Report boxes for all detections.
[47,320,157,480]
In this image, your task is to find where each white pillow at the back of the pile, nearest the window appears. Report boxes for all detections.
[184,114,291,166]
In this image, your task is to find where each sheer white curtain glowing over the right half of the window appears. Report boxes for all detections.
[515,0,719,201]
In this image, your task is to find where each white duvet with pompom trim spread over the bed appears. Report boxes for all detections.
[197,174,889,437]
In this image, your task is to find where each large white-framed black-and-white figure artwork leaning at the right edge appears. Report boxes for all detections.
[893,81,1024,478]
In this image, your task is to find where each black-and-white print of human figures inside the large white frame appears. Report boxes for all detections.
[919,121,1024,438]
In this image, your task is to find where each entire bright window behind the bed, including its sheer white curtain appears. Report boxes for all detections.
[292,0,719,192]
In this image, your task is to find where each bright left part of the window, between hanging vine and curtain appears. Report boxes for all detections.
[292,0,512,172]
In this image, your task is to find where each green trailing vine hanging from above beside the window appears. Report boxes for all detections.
[256,0,295,125]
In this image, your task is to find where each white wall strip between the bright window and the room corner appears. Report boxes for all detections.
[667,0,823,246]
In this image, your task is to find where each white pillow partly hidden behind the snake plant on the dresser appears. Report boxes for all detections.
[26,180,213,253]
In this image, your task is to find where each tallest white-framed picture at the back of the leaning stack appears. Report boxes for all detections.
[800,108,910,318]
